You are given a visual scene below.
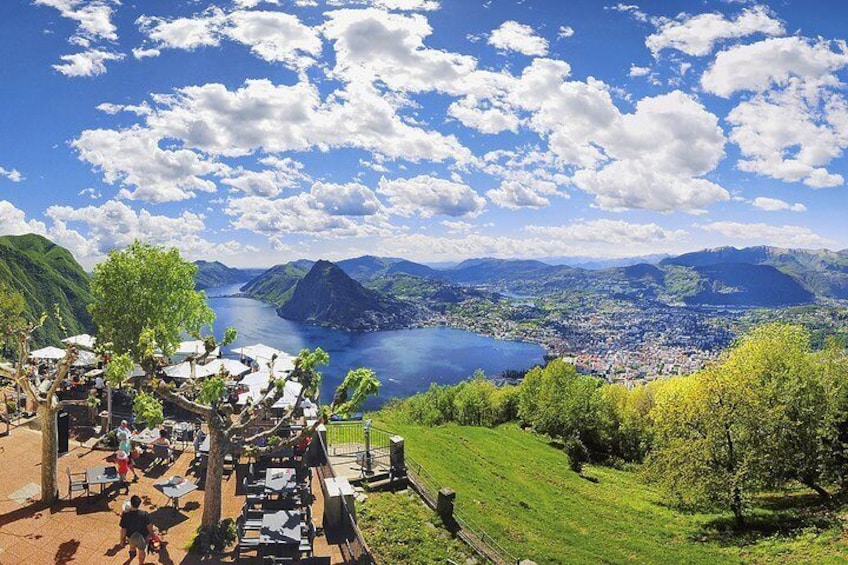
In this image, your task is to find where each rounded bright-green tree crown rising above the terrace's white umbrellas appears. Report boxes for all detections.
[89,241,215,361]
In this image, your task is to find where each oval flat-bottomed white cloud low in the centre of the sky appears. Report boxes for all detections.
[377,175,486,218]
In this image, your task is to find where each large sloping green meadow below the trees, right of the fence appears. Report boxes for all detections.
[375,415,848,565]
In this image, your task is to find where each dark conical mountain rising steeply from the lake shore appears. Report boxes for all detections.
[277,261,416,330]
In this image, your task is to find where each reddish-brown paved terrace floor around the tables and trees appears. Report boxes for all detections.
[0,427,344,565]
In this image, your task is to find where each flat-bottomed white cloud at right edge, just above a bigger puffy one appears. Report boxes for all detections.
[701,37,848,98]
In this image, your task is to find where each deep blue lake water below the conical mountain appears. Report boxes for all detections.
[206,285,544,407]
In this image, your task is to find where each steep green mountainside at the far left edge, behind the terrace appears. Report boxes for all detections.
[0,234,94,346]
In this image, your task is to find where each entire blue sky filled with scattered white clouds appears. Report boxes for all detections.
[0,0,848,268]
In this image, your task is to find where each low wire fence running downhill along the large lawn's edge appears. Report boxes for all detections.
[406,457,520,565]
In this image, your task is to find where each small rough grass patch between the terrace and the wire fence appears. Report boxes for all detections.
[357,490,474,565]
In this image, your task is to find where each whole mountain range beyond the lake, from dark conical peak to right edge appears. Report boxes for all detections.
[232,247,848,327]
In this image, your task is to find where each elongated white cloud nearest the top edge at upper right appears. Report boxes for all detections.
[645,6,785,57]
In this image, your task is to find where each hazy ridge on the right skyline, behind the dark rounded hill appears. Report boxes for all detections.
[660,246,848,299]
